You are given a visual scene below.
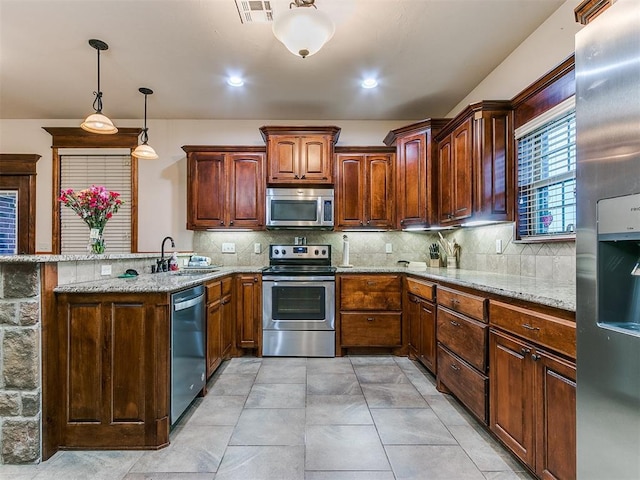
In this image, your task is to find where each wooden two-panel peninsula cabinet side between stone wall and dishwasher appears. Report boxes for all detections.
[56,293,170,449]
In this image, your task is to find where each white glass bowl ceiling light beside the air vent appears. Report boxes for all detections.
[273,0,335,58]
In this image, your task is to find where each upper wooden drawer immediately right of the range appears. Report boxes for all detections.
[340,275,402,310]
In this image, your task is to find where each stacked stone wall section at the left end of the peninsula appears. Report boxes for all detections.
[0,263,42,464]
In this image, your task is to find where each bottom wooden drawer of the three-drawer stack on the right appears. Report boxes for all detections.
[438,345,489,425]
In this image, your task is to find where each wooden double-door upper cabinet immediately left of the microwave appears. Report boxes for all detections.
[182,146,265,230]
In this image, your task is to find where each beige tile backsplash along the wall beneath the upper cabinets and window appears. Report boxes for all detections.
[193,223,576,283]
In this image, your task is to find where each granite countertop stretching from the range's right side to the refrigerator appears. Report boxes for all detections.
[338,267,576,312]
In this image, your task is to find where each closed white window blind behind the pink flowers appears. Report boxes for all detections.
[60,154,132,254]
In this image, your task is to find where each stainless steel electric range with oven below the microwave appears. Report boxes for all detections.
[262,245,336,357]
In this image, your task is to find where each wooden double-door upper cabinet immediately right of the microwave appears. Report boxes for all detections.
[336,147,395,229]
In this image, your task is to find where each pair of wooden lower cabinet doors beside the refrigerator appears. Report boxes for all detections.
[489,328,576,480]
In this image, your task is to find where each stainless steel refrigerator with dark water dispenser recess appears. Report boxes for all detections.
[576,0,640,480]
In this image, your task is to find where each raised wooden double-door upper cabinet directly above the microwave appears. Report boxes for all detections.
[260,126,340,185]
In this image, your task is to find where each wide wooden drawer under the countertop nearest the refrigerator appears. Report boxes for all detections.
[489,300,576,358]
